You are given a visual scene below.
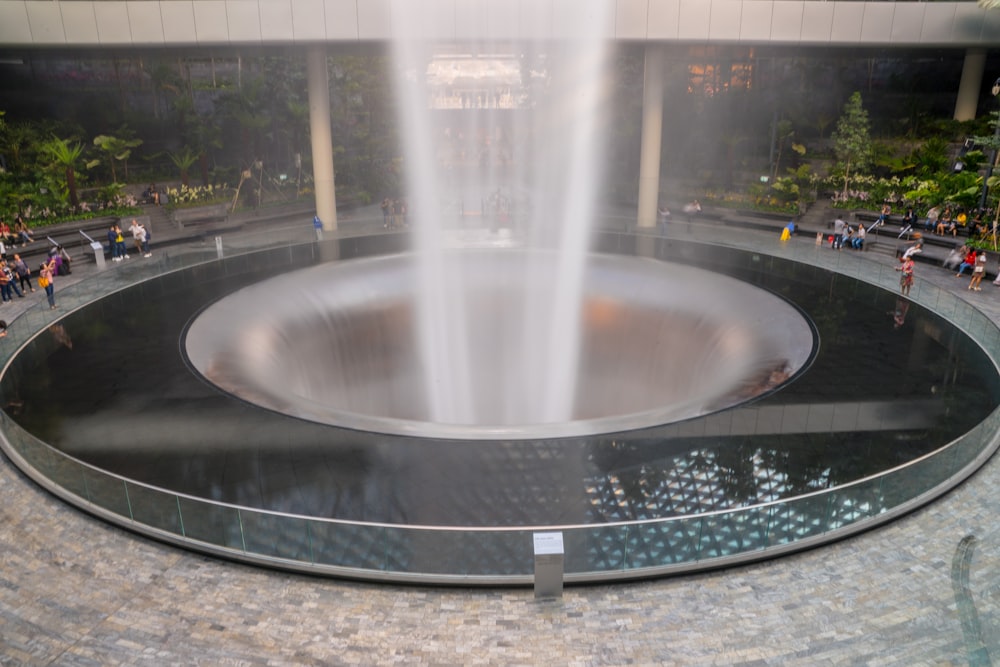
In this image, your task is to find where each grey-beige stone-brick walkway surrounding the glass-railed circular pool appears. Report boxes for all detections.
[0,211,1000,667]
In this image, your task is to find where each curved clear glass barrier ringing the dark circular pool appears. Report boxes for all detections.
[0,222,1000,584]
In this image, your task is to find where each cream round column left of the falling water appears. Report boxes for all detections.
[306,46,337,232]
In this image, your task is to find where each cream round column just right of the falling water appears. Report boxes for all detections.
[637,46,666,227]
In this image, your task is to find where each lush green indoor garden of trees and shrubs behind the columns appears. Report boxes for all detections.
[0,49,1000,243]
